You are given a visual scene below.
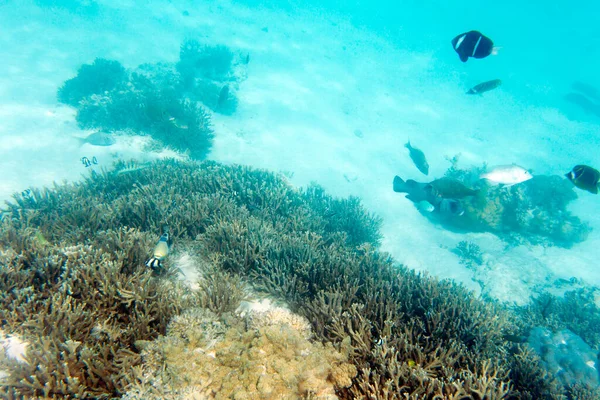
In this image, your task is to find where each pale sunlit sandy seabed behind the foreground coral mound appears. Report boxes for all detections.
[0,0,600,302]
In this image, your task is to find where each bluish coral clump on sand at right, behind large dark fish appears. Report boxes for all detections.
[438,157,590,247]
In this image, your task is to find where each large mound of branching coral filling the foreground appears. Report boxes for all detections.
[0,160,561,399]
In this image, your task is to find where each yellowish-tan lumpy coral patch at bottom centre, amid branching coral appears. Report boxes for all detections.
[124,309,356,399]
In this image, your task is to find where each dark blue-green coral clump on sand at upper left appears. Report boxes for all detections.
[58,40,241,160]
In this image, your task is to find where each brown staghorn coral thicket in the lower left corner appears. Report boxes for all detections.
[0,225,189,398]
